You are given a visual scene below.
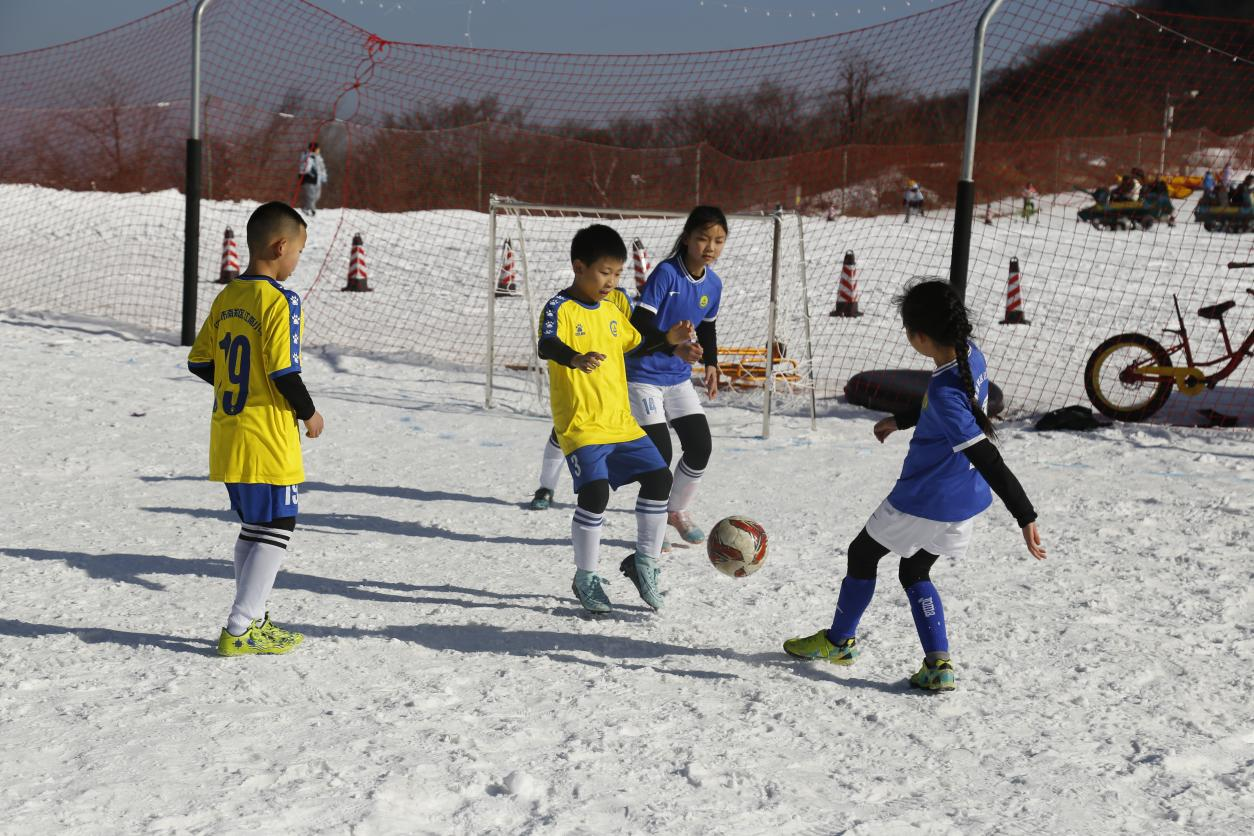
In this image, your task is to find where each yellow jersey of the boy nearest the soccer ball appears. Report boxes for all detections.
[540,291,645,455]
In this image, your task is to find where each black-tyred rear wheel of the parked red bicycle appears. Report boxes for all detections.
[1085,333,1172,421]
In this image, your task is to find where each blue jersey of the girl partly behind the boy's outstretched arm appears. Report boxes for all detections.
[627,253,722,386]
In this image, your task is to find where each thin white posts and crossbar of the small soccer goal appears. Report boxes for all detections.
[484,194,816,439]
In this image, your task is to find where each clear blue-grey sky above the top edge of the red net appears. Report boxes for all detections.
[0,0,946,54]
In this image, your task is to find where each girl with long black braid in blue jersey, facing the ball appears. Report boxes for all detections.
[784,280,1045,691]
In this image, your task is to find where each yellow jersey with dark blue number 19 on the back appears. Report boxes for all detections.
[187,276,305,485]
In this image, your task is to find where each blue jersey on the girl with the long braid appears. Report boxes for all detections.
[888,343,993,523]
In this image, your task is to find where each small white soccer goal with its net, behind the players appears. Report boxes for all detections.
[484,196,815,437]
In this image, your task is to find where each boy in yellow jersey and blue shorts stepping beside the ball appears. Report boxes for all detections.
[539,224,700,613]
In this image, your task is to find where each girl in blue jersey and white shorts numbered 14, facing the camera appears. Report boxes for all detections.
[627,206,727,543]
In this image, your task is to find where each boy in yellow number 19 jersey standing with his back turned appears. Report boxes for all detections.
[187,202,322,656]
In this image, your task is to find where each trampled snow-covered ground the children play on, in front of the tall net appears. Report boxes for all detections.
[0,315,1254,836]
